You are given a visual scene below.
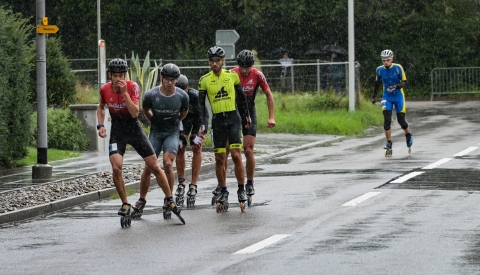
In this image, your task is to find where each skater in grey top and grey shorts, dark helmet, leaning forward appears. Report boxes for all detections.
[134,63,188,222]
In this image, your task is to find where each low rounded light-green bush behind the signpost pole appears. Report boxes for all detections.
[30,108,89,151]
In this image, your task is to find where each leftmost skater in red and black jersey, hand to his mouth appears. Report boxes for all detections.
[97,58,183,227]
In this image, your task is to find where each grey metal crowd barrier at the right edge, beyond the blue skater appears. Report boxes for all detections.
[430,67,480,101]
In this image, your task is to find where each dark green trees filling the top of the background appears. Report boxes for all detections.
[0,0,480,94]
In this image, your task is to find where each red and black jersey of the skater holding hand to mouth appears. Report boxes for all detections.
[100,80,140,125]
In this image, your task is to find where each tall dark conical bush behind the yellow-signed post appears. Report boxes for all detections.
[30,37,77,108]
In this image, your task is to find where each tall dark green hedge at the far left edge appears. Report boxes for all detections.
[0,7,33,167]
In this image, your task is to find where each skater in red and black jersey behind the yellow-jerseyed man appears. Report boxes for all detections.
[227,50,275,204]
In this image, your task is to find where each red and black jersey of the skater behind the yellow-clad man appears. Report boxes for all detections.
[231,67,270,108]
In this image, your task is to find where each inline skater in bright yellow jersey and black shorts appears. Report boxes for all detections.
[198,46,251,212]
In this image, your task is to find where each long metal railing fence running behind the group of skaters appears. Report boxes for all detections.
[69,58,352,96]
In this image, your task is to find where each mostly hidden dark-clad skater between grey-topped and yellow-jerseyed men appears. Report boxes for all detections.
[175,74,209,207]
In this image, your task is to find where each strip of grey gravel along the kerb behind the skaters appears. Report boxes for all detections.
[0,151,215,213]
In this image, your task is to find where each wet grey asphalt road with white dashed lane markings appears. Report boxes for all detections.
[0,102,480,274]
